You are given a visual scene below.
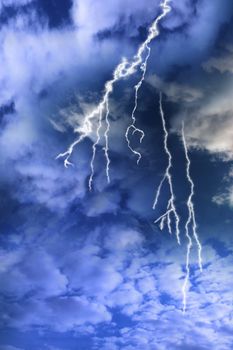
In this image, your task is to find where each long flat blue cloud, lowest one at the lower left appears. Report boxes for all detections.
[8,296,111,332]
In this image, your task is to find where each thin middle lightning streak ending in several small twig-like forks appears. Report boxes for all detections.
[153,92,180,244]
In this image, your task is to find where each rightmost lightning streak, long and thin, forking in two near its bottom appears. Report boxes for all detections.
[182,122,202,313]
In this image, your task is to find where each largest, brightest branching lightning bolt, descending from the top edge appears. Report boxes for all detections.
[57,0,171,190]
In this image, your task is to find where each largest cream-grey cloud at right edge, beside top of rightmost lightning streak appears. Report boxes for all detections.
[173,80,233,160]
